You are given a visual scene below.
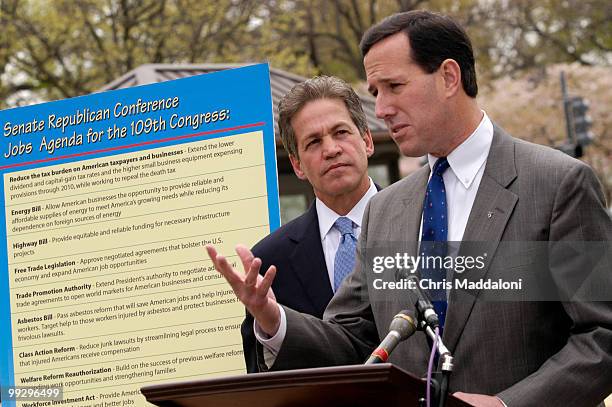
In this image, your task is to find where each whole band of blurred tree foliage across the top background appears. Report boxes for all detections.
[0,0,612,106]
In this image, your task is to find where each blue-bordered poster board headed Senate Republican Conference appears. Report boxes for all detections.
[0,64,280,407]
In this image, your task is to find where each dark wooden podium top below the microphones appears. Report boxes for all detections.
[140,363,469,407]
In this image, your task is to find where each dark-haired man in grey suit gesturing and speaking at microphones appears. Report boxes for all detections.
[208,11,612,407]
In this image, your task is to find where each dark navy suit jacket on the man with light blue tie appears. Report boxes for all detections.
[241,202,334,373]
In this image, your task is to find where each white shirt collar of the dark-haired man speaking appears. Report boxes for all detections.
[427,111,493,188]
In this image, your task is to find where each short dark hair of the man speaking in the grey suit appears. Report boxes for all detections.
[359,11,478,97]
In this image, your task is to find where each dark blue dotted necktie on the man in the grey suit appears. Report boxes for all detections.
[421,157,449,332]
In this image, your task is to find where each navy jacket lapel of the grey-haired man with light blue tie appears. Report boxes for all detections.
[288,203,333,313]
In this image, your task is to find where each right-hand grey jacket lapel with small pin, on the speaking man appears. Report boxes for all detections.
[444,126,518,351]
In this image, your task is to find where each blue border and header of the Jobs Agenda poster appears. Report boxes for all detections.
[0,64,280,398]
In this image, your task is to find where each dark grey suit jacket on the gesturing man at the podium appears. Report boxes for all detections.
[259,127,612,407]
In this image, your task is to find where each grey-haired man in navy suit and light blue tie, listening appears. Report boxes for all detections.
[241,76,377,373]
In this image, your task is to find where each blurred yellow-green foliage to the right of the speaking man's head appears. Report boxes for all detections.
[473,0,612,76]
